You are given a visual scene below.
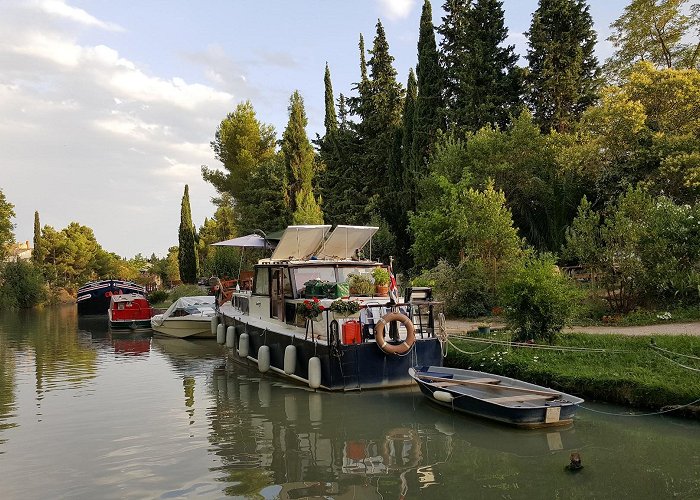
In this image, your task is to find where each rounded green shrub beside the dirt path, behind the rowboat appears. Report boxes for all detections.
[502,254,581,343]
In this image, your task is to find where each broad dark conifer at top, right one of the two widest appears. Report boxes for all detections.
[526,0,601,132]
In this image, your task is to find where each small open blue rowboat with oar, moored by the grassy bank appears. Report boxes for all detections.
[409,366,583,427]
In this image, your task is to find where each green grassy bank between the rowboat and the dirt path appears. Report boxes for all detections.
[445,332,700,419]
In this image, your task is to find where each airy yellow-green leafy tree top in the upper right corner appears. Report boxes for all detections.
[605,0,700,79]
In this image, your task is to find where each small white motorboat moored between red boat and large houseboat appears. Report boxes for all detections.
[151,295,216,339]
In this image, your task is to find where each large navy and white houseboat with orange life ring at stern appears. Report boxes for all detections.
[221,226,442,391]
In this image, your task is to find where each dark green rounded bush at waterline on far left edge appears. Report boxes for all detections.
[0,260,46,309]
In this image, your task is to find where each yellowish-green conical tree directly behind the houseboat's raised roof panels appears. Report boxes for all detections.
[282,90,323,224]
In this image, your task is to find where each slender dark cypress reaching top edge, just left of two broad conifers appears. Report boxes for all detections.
[404,0,442,174]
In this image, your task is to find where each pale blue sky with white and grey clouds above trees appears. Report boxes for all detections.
[0,0,629,258]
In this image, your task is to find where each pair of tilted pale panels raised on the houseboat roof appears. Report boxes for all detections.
[270,225,379,261]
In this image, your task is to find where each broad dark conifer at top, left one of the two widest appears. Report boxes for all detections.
[440,0,522,135]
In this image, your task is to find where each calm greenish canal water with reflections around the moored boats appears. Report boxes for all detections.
[0,307,700,499]
